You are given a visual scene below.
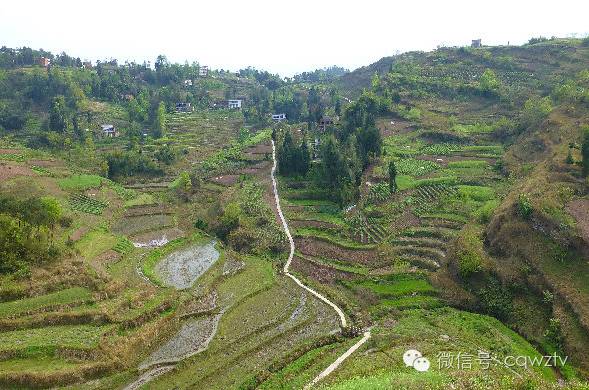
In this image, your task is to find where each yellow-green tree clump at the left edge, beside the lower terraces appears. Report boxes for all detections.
[0,195,63,274]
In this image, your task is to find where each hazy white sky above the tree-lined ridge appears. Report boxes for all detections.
[0,0,589,76]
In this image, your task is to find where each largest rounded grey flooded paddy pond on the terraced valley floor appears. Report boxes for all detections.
[155,240,219,290]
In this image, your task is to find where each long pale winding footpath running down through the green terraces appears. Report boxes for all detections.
[270,140,371,389]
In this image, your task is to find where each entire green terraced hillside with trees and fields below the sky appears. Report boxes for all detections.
[0,38,589,389]
